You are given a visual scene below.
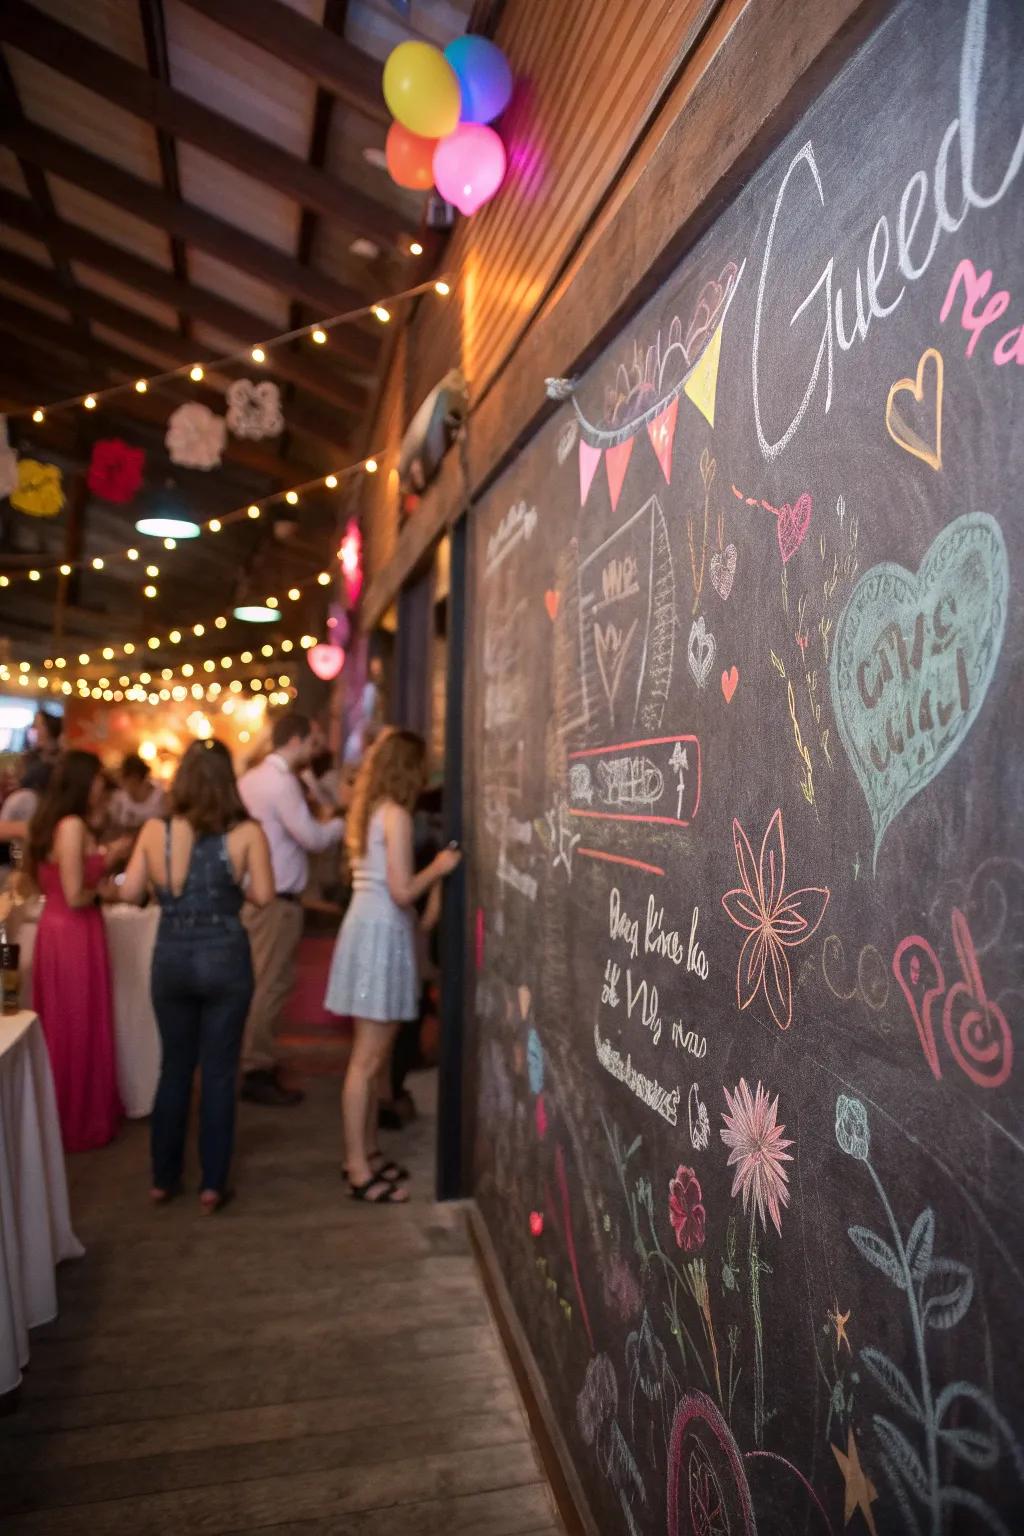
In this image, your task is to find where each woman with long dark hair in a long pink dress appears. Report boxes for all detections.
[28,751,123,1152]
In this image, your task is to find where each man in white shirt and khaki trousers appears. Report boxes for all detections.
[238,714,345,1104]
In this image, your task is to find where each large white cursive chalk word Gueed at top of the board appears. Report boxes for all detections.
[751,0,1024,461]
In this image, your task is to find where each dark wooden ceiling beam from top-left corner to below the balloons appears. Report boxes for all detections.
[0,0,405,243]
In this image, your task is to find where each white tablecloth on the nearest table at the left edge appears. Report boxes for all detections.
[0,1012,84,1393]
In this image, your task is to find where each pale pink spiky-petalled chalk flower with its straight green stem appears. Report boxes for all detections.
[718,1077,792,1450]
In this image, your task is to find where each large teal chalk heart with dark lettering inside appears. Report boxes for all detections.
[831,511,1009,868]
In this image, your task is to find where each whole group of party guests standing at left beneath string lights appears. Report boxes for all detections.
[0,713,459,1213]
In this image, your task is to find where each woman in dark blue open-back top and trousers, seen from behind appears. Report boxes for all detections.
[121,740,273,1215]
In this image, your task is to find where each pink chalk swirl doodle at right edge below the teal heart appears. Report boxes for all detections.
[892,906,1013,1087]
